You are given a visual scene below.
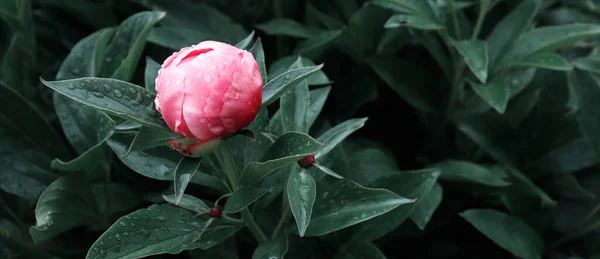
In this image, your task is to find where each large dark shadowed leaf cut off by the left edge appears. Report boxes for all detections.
[0,83,71,201]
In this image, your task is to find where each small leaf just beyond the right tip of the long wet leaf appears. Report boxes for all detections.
[410,183,443,230]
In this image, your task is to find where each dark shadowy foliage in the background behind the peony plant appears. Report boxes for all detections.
[0,0,600,258]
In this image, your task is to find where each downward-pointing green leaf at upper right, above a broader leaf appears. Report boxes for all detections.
[454,40,489,84]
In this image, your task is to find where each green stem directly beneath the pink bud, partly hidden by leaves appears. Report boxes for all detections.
[217,141,269,244]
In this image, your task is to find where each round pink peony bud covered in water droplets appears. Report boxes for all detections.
[154,41,263,147]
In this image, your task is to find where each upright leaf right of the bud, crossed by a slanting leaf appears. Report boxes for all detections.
[279,59,309,133]
